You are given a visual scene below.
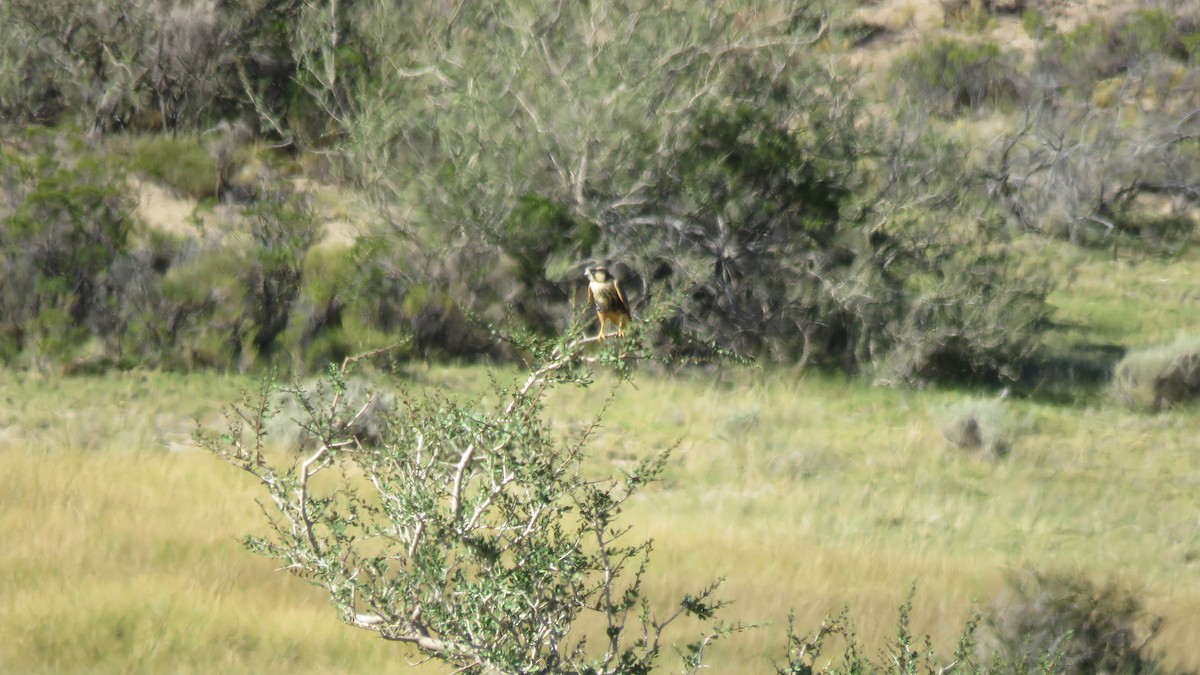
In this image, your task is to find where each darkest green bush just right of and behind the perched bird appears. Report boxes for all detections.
[643,94,870,364]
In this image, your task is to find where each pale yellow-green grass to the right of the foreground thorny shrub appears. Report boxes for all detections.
[568,367,1200,671]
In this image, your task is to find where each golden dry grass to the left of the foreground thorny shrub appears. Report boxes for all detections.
[0,374,436,673]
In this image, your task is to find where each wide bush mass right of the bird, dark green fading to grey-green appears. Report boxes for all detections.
[628,93,1049,381]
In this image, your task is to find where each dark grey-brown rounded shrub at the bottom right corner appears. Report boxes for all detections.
[980,572,1162,674]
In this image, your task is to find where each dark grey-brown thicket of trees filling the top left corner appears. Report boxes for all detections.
[0,0,364,144]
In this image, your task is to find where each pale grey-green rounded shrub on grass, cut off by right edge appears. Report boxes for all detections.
[1112,336,1200,411]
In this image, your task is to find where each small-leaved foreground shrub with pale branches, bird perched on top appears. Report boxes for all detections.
[198,335,740,675]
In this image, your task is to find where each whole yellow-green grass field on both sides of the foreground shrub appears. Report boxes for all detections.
[7,243,1200,675]
